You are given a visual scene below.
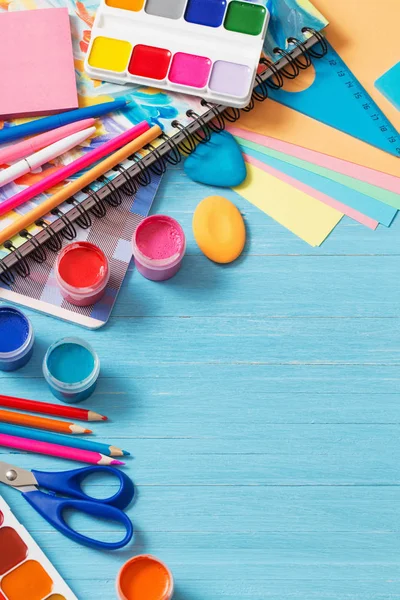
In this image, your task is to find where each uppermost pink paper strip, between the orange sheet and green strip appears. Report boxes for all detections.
[227,126,400,194]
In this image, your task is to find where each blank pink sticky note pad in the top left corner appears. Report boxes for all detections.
[0,8,78,119]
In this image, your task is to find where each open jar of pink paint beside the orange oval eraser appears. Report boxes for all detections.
[132,215,186,281]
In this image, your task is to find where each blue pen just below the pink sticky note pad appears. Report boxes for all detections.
[0,98,129,144]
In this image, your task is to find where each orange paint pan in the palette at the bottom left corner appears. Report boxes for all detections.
[1,560,53,600]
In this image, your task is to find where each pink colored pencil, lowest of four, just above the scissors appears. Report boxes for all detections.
[0,433,125,465]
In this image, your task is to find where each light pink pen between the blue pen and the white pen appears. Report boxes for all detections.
[0,119,95,165]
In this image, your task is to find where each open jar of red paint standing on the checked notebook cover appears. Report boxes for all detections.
[55,242,110,306]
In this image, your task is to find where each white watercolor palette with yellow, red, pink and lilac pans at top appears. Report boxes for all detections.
[85,0,270,108]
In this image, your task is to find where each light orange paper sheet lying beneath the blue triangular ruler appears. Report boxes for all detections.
[238,0,400,177]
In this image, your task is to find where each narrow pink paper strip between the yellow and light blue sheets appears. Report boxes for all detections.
[244,154,378,229]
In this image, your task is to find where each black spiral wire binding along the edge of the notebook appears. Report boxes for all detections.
[0,27,328,287]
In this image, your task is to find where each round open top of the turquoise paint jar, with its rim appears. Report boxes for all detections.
[47,342,94,383]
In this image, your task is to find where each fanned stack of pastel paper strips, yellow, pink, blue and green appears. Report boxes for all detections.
[229,127,400,246]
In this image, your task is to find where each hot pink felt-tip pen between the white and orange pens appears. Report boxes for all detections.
[0,121,150,215]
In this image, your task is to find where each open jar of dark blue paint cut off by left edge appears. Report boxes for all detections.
[0,306,35,371]
